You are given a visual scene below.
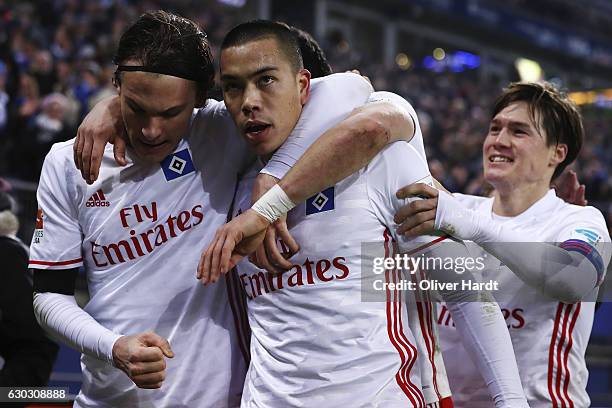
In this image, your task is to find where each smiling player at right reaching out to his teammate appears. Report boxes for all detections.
[398,83,611,408]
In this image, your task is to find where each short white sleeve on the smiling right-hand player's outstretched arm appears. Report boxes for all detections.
[556,207,612,285]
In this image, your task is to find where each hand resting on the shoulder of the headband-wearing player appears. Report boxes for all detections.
[73,96,127,184]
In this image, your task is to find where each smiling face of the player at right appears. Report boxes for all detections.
[482,102,567,192]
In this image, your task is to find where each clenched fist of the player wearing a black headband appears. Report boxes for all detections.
[113,332,174,389]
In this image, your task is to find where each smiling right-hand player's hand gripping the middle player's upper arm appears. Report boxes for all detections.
[393,183,438,237]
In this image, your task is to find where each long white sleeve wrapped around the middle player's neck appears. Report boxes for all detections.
[261,73,372,179]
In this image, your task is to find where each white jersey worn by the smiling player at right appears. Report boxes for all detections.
[438,190,610,408]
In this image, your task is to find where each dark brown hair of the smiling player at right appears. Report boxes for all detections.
[491,82,584,180]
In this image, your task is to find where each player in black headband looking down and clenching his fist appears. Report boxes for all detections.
[30,11,393,407]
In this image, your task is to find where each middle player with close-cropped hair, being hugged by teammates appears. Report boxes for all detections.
[199,22,526,407]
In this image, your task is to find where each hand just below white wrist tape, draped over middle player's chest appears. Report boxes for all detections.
[197,210,270,285]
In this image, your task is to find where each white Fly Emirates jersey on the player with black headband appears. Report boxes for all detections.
[30,101,246,407]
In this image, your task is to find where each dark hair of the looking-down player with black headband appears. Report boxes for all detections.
[113,10,215,100]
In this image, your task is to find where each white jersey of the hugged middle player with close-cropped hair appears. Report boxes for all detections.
[235,142,448,407]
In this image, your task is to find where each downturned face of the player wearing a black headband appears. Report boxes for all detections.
[119,72,197,163]
